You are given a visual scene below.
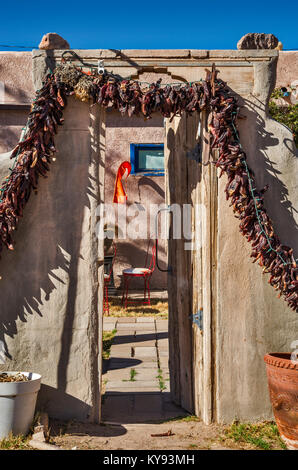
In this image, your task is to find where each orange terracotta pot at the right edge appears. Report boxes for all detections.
[264,353,298,450]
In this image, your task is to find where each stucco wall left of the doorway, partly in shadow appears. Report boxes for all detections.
[0,98,104,421]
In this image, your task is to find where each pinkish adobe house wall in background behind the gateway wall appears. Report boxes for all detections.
[0,52,298,290]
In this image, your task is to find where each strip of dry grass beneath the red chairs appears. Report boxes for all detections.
[109,297,168,318]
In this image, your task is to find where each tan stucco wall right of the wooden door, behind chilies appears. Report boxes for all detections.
[215,61,298,422]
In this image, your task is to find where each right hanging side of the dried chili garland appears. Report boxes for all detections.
[205,67,298,311]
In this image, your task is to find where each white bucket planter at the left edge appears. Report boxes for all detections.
[0,371,41,439]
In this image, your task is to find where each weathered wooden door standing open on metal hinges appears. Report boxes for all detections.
[165,113,217,423]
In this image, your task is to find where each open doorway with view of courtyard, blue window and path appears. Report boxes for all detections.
[102,103,186,423]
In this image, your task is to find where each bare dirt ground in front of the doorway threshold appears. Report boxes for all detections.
[51,418,281,450]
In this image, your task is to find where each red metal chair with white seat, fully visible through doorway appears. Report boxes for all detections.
[122,240,156,308]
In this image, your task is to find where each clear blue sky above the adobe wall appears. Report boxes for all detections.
[0,0,298,50]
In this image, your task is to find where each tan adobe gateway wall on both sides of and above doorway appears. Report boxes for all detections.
[0,50,298,422]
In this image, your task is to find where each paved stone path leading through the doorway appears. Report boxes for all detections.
[102,317,186,424]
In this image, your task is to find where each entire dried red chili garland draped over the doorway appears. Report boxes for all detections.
[0,63,298,312]
